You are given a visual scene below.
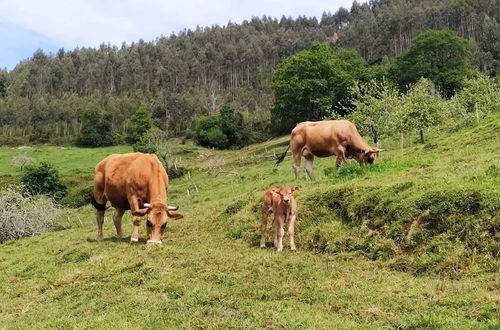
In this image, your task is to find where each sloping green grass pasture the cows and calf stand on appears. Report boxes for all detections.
[0,117,500,329]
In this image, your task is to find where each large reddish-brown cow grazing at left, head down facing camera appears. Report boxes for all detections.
[92,152,182,243]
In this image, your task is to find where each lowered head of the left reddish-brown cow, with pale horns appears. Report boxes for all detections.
[144,202,182,244]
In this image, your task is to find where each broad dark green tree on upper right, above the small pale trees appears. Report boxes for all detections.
[391,30,475,98]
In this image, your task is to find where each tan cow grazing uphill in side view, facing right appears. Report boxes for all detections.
[276,120,382,180]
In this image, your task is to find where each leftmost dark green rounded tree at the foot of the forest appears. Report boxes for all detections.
[76,105,114,147]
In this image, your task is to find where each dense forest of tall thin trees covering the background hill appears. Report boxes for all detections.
[0,0,500,142]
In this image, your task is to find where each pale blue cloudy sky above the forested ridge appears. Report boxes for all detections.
[0,0,353,70]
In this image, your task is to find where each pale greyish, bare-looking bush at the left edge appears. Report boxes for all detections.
[0,187,60,243]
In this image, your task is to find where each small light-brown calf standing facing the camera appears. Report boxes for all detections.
[260,186,299,251]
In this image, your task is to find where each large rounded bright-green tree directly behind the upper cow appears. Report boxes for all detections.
[271,44,366,133]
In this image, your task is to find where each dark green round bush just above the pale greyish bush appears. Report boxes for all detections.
[21,162,67,201]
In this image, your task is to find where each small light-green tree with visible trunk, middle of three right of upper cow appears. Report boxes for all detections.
[401,78,445,143]
